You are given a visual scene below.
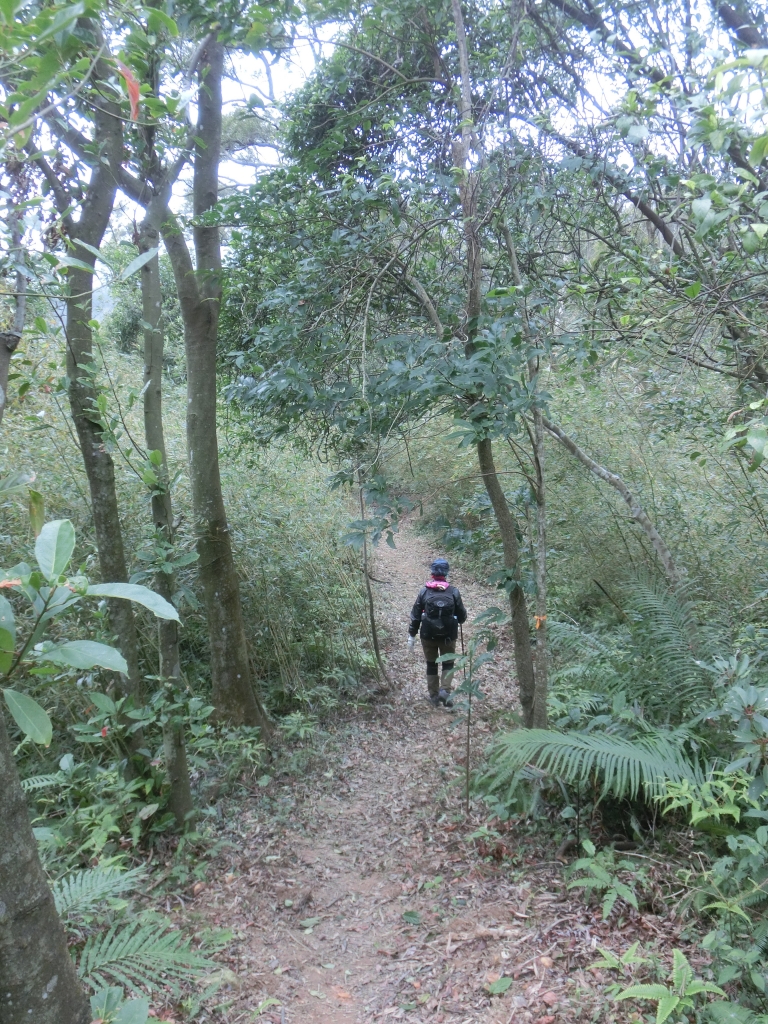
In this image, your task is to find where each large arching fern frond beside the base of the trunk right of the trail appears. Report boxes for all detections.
[481,729,703,798]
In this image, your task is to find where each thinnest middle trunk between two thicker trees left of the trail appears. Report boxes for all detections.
[138,214,195,828]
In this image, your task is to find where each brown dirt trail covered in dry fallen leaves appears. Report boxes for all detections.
[168,528,696,1024]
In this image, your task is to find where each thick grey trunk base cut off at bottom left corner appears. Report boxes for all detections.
[0,714,91,1024]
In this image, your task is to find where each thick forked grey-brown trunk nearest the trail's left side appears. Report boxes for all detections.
[162,38,271,735]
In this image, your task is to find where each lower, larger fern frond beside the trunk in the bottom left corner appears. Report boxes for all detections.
[78,922,215,991]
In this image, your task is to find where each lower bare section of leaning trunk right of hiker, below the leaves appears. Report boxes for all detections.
[477,438,536,728]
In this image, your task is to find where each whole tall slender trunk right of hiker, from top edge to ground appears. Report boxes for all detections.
[451,0,536,726]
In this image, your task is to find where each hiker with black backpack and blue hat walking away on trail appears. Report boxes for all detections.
[408,558,467,708]
